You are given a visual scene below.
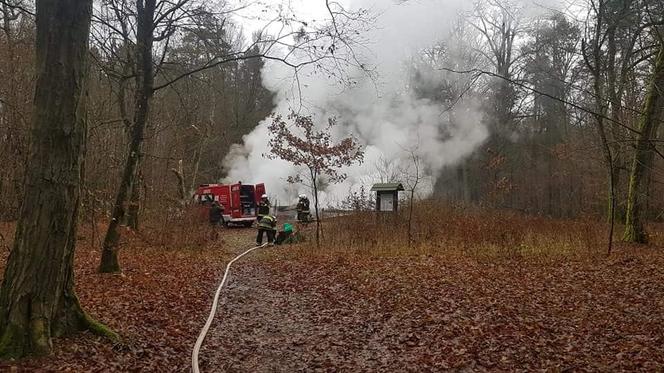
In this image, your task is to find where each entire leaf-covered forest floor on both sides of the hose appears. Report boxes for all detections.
[0,221,664,372]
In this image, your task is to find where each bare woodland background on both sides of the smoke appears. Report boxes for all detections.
[0,0,664,228]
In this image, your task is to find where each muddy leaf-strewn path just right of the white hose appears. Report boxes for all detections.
[201,256,402,372]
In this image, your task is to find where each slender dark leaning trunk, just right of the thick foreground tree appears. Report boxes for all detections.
[99,0,155,273]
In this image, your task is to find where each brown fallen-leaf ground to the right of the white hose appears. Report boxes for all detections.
[201,248,664,371]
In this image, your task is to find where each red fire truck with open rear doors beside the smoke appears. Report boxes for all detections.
[194,182,265,227]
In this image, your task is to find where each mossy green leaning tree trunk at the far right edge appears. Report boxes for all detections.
[623,47,664,243]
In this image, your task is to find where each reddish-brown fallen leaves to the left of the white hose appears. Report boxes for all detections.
[0,222,239,372]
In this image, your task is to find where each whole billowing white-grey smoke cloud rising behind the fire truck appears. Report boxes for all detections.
[224,1,572,204]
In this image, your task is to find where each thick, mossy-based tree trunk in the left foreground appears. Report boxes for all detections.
[0,0,117,358]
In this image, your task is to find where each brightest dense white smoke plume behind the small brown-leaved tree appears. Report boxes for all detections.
[224,0,560,205]
